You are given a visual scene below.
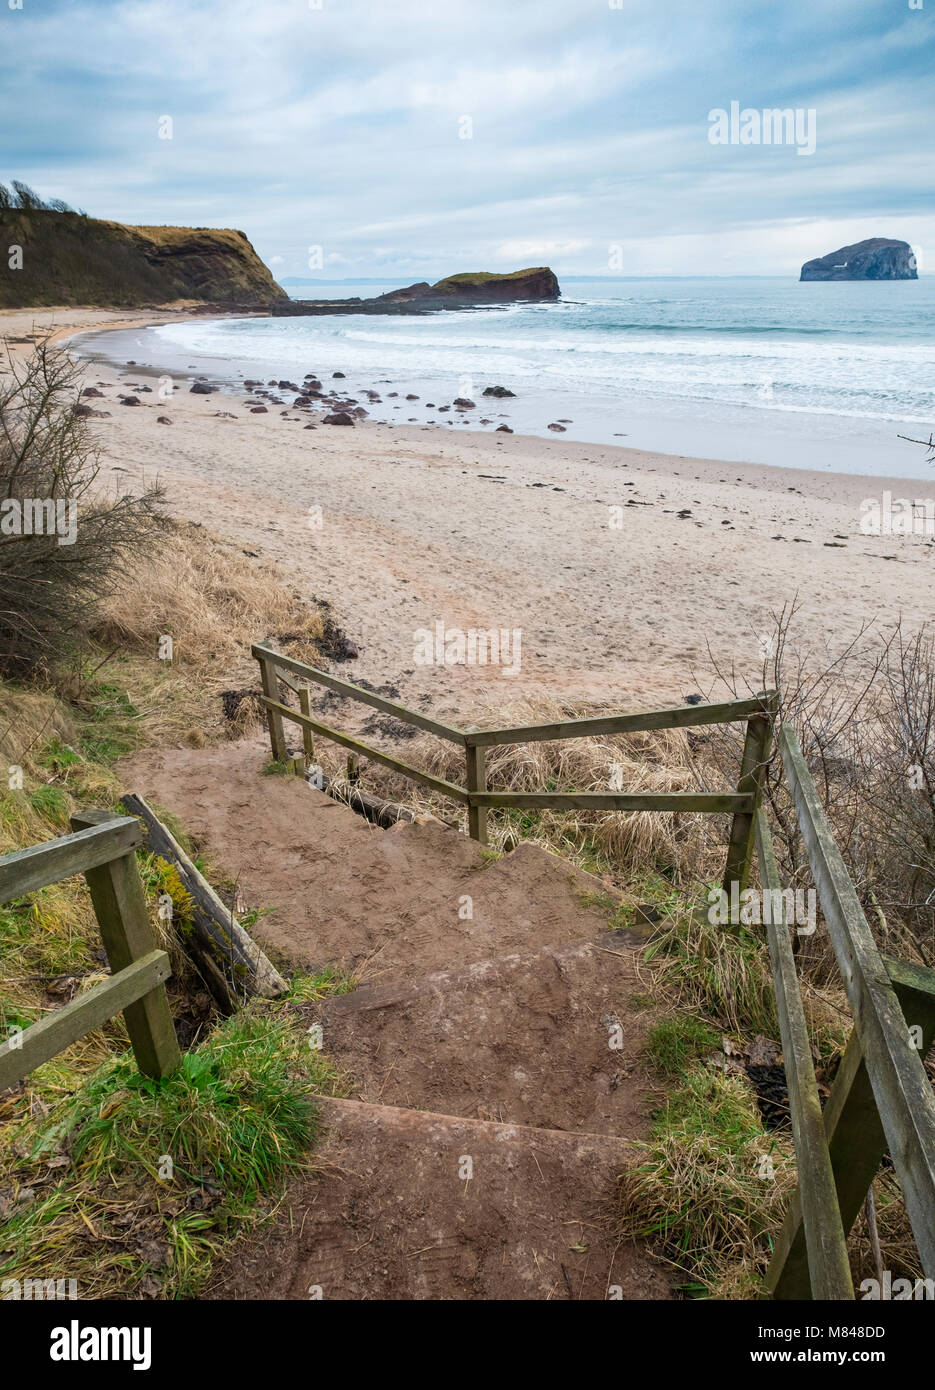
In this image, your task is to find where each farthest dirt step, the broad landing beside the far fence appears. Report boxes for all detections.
[122,742,627,981]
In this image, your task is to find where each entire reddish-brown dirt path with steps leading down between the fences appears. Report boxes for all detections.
[124,739,671,1300]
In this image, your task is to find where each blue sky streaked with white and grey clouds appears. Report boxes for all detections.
[0,0,935,282]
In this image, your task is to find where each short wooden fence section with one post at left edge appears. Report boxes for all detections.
[0,810,181,1091]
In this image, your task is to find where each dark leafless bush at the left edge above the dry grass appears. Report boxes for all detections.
[0,343,164,676]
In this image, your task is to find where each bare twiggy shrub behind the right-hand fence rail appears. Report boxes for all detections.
[707,602,935,980]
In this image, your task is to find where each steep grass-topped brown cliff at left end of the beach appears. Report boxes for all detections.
[0,209,288,309]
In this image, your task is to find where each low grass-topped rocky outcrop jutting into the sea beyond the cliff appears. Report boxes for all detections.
[270,265,561,317]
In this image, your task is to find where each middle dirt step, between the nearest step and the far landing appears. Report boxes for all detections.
[317,937,653,1136]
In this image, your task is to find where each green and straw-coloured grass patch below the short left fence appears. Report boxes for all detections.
[0,1005,343,1298]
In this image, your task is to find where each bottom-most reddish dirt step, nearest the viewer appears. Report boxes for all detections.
[208,1099,671,1300]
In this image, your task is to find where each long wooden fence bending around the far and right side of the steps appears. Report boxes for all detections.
[253,645,935,1300]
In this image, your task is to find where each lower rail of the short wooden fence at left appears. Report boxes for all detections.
[0,951,172,1091]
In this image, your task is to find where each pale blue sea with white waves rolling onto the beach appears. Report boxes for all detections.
[72,275,935,480]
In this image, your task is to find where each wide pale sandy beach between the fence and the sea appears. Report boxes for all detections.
[0,309,935,714]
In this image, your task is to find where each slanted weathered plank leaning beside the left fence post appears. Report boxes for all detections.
[122,792,289,1004]
